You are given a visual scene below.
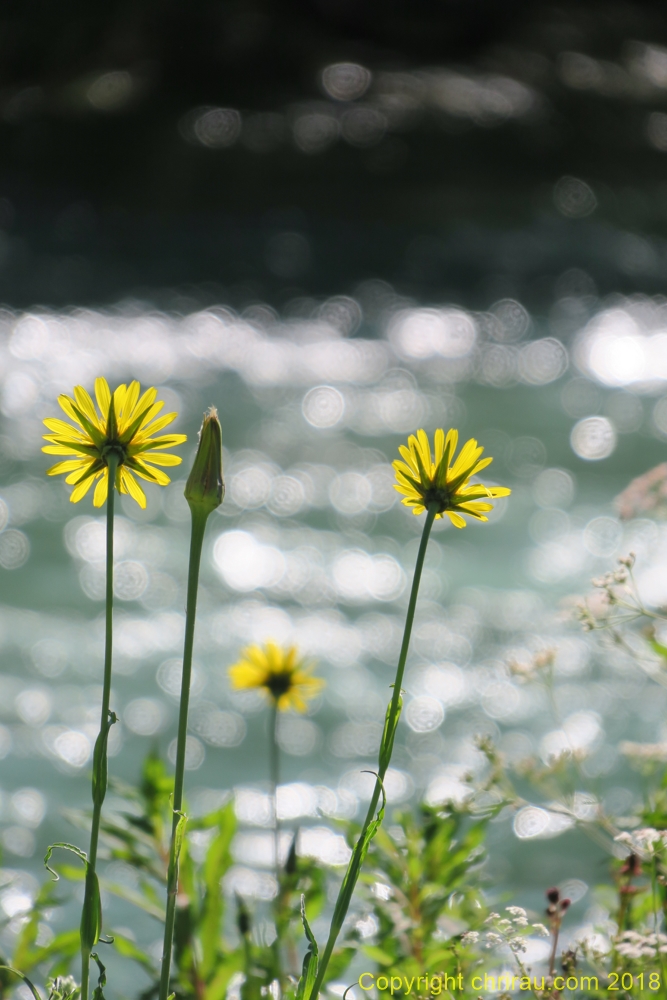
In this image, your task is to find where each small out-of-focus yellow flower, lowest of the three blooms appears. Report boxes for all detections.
[229,642,324,712]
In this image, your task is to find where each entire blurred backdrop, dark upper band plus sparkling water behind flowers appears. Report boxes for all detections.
[0,0,667,989]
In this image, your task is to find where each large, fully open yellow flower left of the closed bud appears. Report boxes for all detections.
[42,378,186,507]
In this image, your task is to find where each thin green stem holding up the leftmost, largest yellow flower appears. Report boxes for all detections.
[81,452,118,1000]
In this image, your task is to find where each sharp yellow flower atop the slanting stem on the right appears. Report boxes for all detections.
[393,428,512,528]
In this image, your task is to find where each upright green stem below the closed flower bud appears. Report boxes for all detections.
[160,507,208,1000]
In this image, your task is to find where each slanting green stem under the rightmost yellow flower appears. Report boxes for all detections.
[304,504,437,1000]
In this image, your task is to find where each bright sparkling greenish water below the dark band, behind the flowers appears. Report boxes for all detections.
[0,292,667,989]
